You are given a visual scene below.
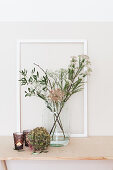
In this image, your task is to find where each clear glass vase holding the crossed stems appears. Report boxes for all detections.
[43,107,70,147]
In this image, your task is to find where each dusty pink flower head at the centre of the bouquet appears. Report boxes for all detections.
[48,88,64,102]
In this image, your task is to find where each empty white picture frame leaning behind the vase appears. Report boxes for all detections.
[16,39,88,137]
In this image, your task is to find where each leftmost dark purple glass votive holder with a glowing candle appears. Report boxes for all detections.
[13,132,24,150]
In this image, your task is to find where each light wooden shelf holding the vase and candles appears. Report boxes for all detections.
[0,136,113,160]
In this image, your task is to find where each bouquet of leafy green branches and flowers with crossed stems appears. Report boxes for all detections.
[20,55,91,138]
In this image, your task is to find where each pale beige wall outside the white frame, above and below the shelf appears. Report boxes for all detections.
[0,22,113,170]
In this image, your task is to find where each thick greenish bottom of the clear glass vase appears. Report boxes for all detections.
[50,136,69,147]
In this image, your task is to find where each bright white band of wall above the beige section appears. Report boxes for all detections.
[0,0,113,22]
